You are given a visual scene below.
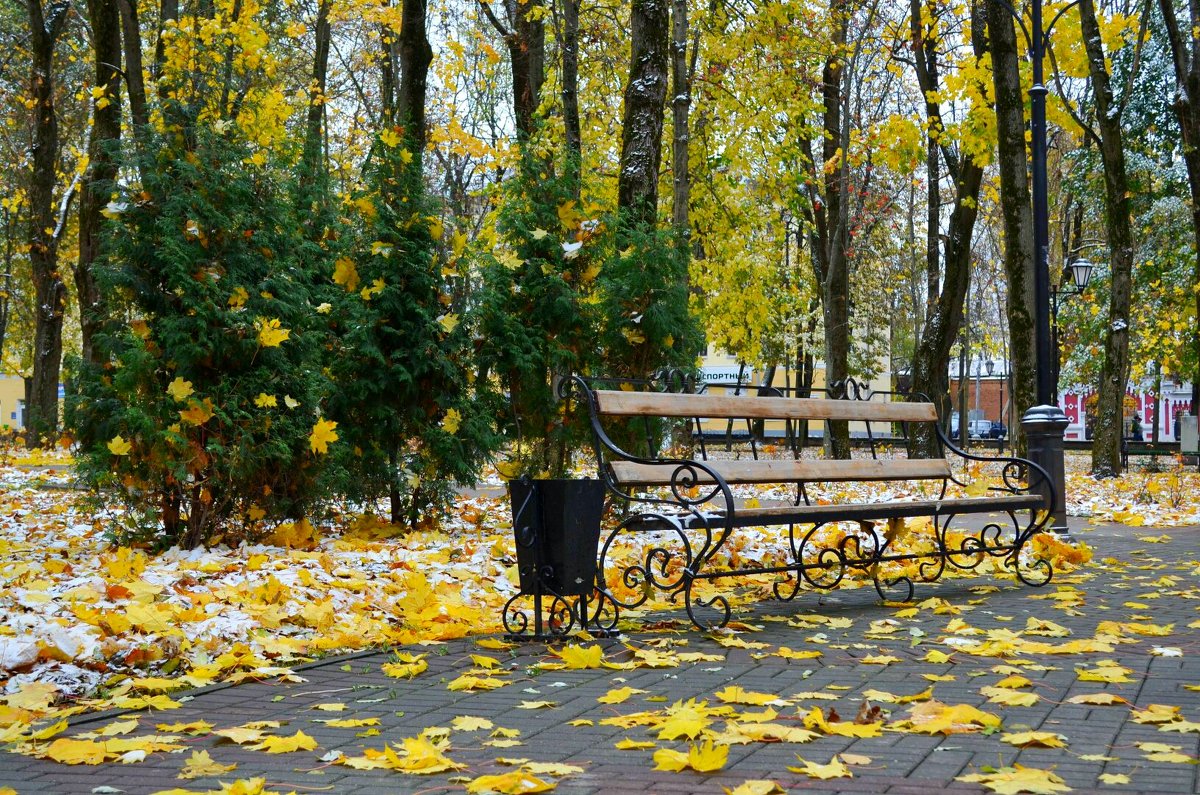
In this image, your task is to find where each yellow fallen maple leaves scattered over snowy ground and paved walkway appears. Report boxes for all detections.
[0,451,1200,795]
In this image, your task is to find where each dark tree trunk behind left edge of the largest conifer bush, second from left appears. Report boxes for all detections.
[74,0,121,363]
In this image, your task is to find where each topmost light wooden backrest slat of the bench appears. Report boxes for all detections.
[593,389,937,423]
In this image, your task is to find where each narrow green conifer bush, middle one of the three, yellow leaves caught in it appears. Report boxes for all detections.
[329,127,493,527]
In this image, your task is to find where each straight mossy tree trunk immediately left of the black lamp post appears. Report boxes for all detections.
[988,0,1037,454]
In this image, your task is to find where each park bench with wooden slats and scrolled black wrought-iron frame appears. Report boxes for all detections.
[570,376,1052,628]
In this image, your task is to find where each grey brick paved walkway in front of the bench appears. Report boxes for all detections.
[0,526,1200,795]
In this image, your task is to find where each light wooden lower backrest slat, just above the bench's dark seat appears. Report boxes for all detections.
[610,459,950,486]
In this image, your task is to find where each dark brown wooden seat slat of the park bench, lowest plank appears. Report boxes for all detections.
[636,495,1043,530]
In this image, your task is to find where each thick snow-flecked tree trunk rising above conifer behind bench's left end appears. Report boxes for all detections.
[617,0,671,227]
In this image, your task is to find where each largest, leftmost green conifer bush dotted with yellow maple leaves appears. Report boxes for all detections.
[71,118,337,548]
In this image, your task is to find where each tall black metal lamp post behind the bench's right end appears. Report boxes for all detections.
[1021,0,1069,534]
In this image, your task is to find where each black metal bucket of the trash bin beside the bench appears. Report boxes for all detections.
[509,478,605,597]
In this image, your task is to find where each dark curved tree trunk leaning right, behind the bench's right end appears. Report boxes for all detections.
[908,2,988,456]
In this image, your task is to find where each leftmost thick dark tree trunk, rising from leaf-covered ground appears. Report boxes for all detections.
[25,0,68,446]
